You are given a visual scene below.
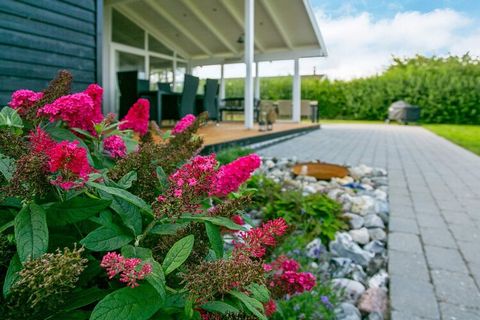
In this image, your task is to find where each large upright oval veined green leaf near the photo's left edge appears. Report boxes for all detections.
[15,203,48,262]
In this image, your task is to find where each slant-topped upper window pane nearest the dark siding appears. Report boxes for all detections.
[112,9,145,49]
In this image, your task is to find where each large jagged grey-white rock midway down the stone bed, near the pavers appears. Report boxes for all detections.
[329,229,381,266]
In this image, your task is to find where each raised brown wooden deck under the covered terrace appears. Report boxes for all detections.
[198,122,320,150]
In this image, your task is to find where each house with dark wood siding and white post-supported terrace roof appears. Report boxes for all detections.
[0,0,327,128]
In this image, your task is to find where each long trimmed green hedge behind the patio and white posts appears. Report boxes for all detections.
[226,54,480,124]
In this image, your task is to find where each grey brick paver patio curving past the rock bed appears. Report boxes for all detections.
[260,124,480,320]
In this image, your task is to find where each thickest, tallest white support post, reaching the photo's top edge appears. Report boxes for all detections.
[244,0,255,129]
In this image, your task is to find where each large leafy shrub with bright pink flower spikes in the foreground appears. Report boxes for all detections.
[0,72,315,320]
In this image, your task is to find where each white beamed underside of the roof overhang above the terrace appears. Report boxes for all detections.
[105,0,327,66]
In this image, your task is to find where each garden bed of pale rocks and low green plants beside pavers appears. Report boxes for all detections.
[249,158,389,320]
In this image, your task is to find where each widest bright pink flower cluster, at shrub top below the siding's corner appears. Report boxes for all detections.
[37,84,103,135]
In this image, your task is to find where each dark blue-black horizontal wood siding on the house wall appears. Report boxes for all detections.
[0,0,103,107]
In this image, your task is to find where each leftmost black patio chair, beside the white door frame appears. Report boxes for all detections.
[117,71,150,119]
